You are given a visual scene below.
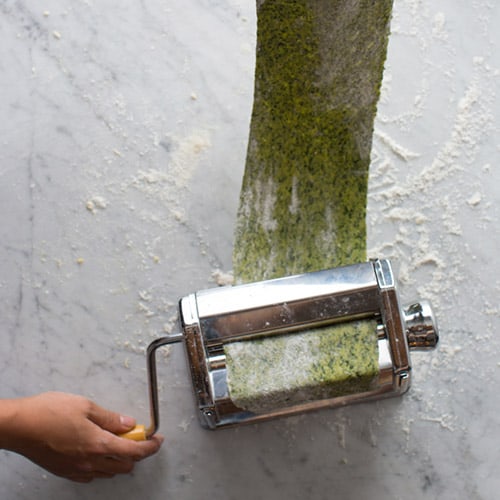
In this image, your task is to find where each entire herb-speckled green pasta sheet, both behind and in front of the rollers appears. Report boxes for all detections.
[225,0,392,412]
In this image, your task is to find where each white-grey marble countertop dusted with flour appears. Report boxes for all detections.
[0,0,500,500]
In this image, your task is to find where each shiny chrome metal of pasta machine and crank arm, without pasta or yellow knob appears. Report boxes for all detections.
[141,259,438,435]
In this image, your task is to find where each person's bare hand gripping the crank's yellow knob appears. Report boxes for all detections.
[2,392,163,482]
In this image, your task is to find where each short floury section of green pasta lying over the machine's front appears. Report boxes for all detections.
[225,320,378,413]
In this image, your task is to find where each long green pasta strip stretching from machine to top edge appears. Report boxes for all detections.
[233,0,392,282]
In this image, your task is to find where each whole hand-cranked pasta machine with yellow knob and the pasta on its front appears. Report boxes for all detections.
[121,259,438,439]
